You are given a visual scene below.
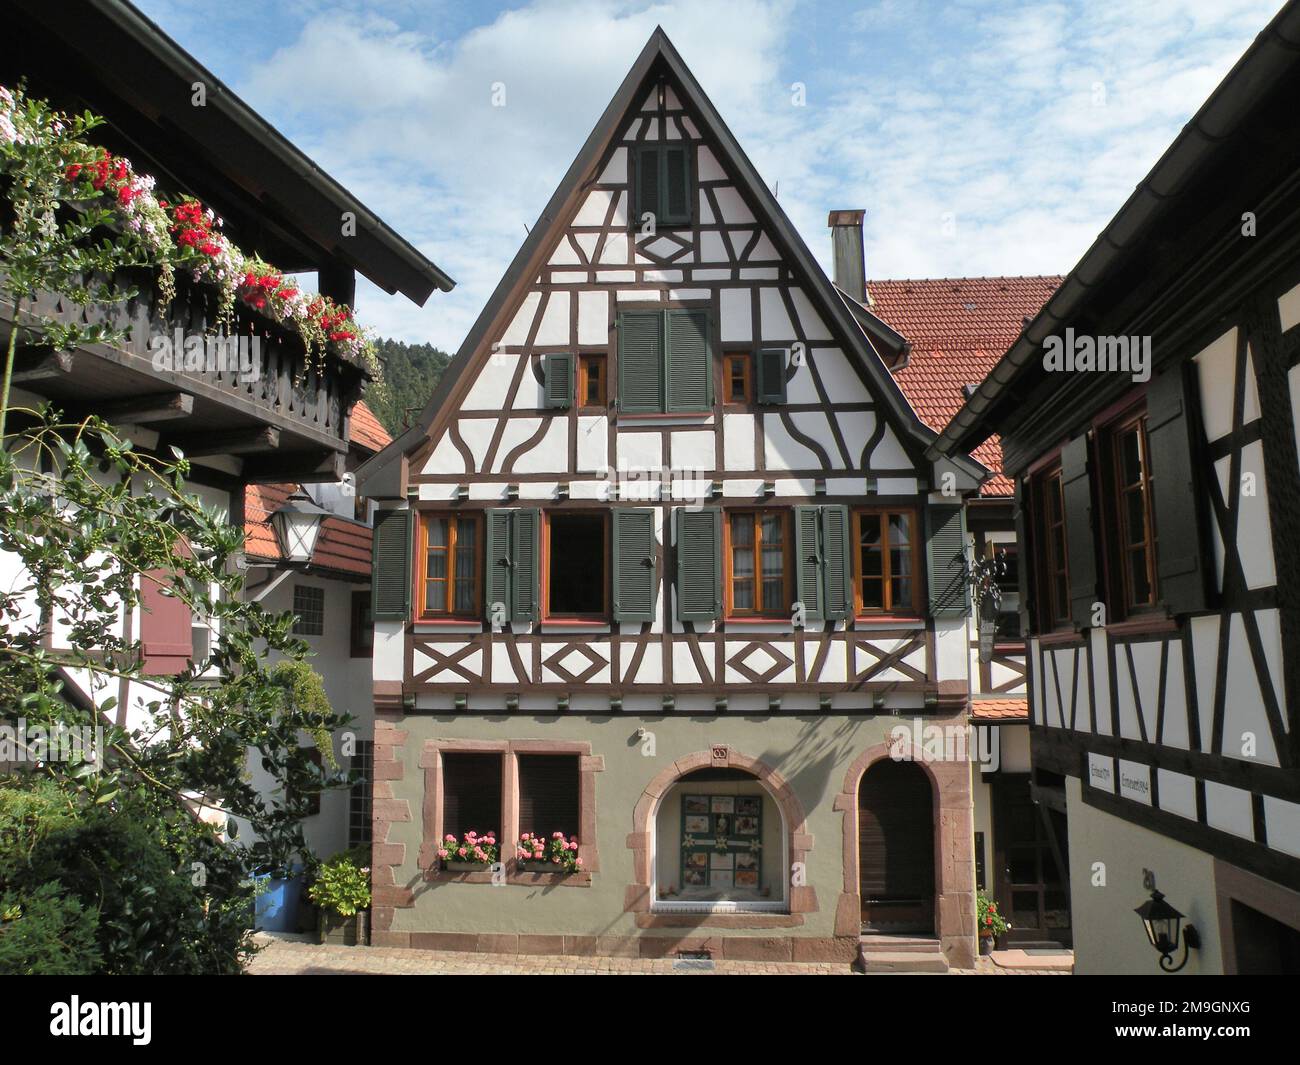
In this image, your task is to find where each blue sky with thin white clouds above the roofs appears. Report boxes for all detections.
[137,0,1281,350]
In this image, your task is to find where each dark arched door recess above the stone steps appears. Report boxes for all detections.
[858,759,935,934]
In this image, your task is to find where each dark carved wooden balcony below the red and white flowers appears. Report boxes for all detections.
[0,272,369,481]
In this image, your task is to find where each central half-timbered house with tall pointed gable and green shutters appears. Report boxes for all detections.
[359,30,985,966]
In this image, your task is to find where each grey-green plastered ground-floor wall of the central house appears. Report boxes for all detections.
[389,714,972,936]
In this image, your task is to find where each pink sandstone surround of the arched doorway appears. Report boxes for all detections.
[833,739,975,969]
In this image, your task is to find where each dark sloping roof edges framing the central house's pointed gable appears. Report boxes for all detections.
[358,29,984,498]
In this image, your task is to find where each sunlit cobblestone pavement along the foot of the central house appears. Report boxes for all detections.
[248,934,1071,977]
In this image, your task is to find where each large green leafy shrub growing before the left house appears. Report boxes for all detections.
[0,408,355,971]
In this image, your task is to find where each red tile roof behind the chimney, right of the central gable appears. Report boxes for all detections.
[867,277,1063,495]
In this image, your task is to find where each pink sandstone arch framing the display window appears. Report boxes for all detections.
[623,748,818,914]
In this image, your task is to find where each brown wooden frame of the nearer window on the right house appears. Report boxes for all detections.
[1097,403,1160,622]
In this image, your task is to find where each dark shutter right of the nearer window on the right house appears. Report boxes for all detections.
[1147,364,1214,614]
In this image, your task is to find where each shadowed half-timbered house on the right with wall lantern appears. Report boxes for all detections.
[933,3,1300,973]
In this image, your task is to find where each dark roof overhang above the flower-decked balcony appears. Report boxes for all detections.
[0,0,455,304]
